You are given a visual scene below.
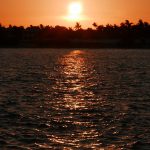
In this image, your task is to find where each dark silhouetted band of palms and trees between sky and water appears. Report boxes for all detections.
[0,20,150,48]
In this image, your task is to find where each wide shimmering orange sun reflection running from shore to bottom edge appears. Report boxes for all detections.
[47,50,129,149]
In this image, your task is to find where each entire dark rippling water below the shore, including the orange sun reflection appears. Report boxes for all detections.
[0,49,150,150]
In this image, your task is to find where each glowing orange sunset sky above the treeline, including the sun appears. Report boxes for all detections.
[0,0,150,27]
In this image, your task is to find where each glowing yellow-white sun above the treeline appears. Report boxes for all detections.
[68,2,82,21]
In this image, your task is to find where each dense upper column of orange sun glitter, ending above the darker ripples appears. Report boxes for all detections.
[61,50,93,109]
